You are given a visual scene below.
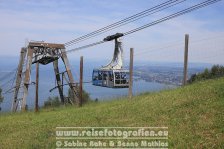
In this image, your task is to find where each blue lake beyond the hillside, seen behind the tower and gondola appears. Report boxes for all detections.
[0,60,210,111]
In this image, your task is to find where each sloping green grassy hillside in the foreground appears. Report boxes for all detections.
[0,78,224,148]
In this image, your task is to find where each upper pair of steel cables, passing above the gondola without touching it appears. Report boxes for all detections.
[65,0,186,46]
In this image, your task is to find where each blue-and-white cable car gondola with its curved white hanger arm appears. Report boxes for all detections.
[92,33,129,88]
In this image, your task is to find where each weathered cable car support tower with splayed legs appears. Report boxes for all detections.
[12,42,80,111]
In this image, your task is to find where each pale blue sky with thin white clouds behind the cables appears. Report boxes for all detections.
[0,0,224,63]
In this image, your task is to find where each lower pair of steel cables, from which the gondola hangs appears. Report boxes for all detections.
[66,0,222,52]
